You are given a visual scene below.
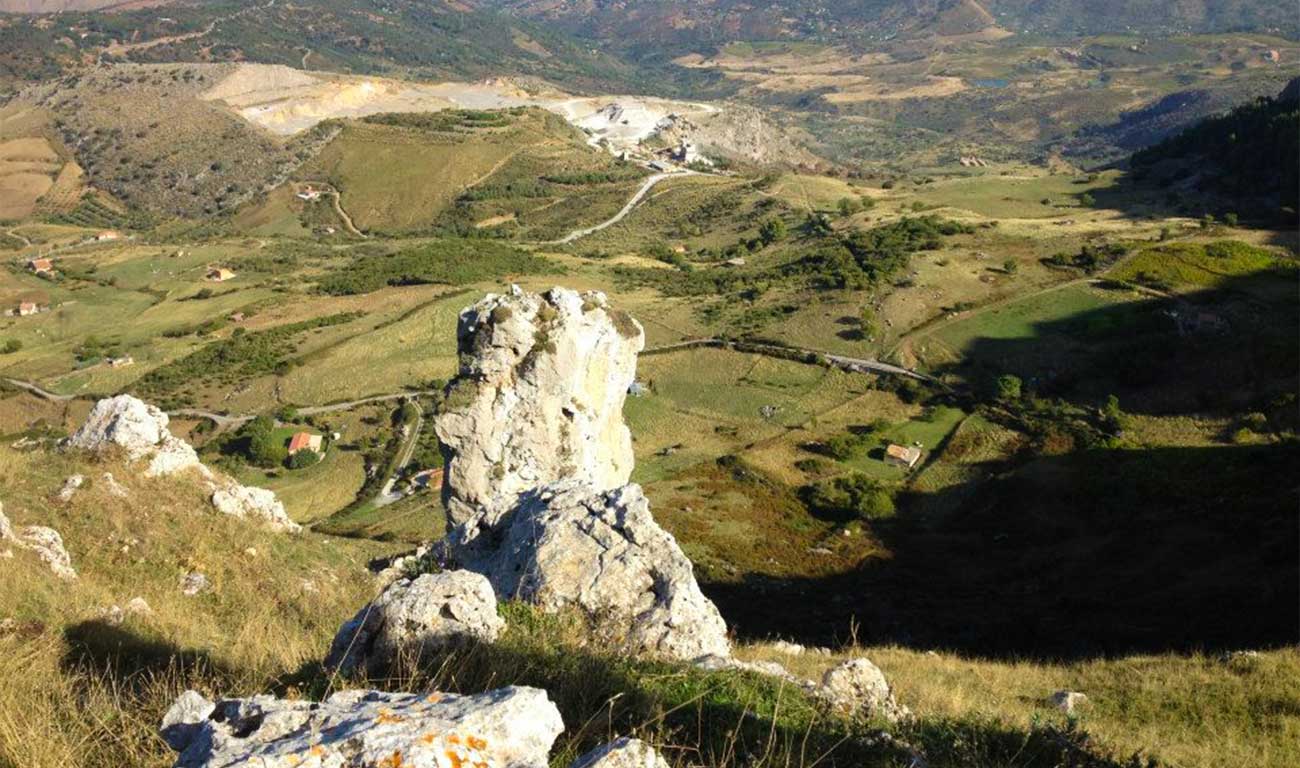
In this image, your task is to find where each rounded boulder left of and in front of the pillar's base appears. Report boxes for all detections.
[325,570,506,674]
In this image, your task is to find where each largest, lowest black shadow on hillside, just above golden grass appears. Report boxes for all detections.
[702,444,1300,659]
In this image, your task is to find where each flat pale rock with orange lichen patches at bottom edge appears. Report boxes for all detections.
[163,686,564,768]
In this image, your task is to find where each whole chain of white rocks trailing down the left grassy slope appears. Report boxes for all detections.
[65,395,300,531]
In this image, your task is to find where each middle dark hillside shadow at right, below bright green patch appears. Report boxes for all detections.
[932,272,1300,415]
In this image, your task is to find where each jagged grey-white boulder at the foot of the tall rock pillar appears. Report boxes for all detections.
[452,480,731,659]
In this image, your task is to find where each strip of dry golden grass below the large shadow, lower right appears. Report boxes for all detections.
[740,645,1300,768]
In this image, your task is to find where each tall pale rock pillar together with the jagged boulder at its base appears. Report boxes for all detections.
[437,288,731,659]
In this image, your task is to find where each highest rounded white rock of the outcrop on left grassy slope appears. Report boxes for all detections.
[68,395,199,477]
